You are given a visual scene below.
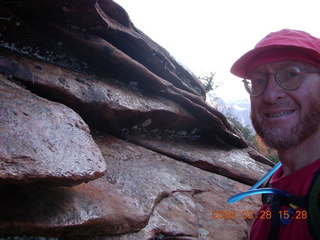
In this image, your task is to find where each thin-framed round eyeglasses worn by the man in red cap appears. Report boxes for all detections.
[243,65,320,97]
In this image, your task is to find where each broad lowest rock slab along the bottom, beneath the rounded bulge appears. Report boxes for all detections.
[0,136,259,240]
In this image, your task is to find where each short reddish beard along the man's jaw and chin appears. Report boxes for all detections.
[251,101,320,150]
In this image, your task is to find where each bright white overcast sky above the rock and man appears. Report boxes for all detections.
[115,0,320,101]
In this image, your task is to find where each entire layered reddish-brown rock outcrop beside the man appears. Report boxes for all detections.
[0,0,273,240]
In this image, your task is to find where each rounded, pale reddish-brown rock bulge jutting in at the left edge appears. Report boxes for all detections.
[0,75,105,185]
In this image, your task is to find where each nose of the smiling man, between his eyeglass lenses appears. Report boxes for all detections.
[262,74,285,104]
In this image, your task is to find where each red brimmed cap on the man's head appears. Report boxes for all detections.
[231,29,320,78]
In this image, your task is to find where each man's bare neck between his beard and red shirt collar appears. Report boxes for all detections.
[277,130,320,176]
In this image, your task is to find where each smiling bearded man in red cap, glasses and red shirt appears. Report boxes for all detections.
[231,29,320,240]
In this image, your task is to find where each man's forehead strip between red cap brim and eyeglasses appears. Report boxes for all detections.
[248,60,319,75]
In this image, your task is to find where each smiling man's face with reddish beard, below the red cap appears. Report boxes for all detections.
[250,61,320,150]
